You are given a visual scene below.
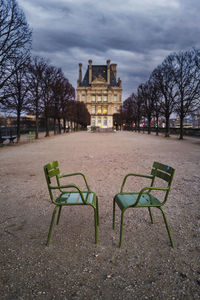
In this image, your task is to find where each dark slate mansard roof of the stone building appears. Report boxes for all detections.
[80,65,119,86]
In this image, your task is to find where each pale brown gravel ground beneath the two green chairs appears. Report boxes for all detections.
[0,132,200,300]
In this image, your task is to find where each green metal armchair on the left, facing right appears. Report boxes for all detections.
[44,161,99,246]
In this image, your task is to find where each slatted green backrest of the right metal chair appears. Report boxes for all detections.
[151,162,175,204]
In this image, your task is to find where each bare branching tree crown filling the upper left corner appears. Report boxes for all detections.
[0,0,31,89]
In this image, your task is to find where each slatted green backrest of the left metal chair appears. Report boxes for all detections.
[44,161,60,201]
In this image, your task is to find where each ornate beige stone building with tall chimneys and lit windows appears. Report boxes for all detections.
[77,60,122,128]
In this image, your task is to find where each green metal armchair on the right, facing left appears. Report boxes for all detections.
[113,162,175,247]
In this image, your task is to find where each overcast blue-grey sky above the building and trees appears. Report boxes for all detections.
[18,0,200,100]
